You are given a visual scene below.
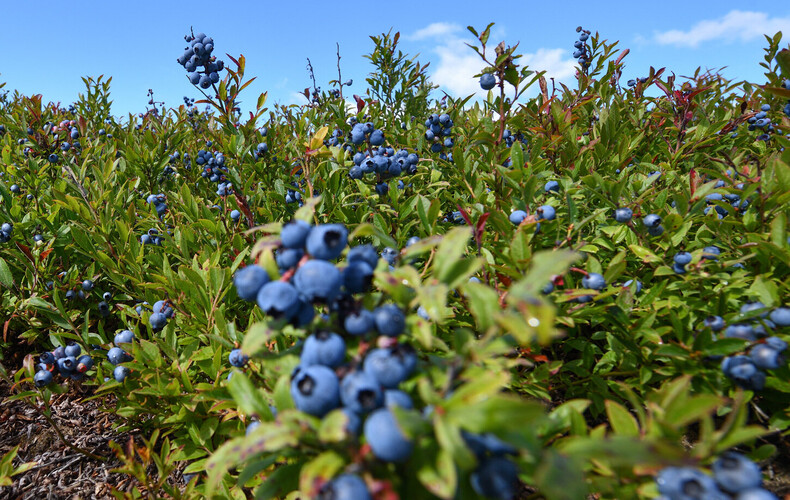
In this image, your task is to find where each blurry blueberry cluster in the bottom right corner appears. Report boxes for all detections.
[656,451,778,500]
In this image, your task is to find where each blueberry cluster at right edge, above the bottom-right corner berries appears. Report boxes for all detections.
[704,302,790,391]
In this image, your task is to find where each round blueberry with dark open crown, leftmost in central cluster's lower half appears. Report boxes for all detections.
[291,365,340,417]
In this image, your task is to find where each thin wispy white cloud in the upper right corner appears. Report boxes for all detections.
[654,10,790,47]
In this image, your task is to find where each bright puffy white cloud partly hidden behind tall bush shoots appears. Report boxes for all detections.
[412,23,576,98]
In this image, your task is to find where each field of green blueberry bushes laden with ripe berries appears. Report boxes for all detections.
[0,25,790,500]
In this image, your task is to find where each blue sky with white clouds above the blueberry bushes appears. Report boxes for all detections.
[0,0,790,116]
